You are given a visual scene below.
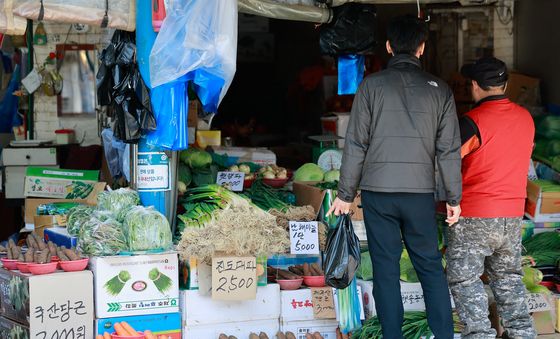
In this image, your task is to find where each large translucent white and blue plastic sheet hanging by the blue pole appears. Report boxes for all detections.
[150,0,237,112]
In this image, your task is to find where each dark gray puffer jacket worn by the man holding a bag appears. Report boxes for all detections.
[338,54,462,206]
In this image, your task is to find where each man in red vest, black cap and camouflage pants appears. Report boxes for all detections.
[446,58,536,339]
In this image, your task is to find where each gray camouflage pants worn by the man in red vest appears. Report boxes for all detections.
[446,218,536,339]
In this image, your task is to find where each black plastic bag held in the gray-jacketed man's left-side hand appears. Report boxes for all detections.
[323,214,361,289]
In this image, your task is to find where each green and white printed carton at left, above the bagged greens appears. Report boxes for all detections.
[24,166,99,199]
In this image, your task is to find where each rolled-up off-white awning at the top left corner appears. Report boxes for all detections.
[14,0,136,32]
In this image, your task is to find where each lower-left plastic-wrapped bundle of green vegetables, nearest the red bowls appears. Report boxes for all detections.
[78,217,128,256]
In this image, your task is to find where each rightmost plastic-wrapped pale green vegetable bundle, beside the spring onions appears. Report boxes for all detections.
[123,206,172,251]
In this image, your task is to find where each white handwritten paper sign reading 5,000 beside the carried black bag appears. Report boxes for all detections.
[290,221,320,254]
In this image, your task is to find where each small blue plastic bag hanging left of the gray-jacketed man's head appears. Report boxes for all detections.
[338,54,365,95]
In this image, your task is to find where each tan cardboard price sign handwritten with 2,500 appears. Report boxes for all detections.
[212,257,257,301]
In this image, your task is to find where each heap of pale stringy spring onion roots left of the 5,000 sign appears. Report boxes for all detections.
[177,185,290,263]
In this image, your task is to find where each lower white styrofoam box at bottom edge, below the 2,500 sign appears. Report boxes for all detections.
[183,320,280,339]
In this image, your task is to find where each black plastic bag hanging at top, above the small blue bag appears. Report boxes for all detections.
[319,3,377,55]
